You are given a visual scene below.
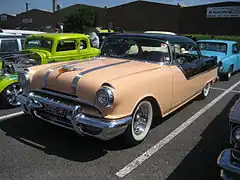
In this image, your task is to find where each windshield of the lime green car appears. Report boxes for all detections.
[25,39,52,50]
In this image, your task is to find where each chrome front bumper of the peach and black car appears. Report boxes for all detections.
[17,93,132,140]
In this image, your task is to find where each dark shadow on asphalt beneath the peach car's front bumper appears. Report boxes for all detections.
[0,115,134,162]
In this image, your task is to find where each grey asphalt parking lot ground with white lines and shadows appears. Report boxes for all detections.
[0,74,240,180]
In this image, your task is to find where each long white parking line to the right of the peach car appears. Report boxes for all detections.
[115,81,240,178]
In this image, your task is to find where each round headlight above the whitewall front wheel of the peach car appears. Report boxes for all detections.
[96,86,114,107]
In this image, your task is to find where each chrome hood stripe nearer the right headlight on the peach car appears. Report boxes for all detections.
[72,61,130,93]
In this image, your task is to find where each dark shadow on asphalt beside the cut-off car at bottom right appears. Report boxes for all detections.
[167,94,240,180]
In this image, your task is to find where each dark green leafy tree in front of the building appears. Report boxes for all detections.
[63,6,96,33]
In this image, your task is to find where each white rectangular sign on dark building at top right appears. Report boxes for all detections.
[207,6,240,18]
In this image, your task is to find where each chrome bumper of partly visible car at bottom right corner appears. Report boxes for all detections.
[217,149,240,180]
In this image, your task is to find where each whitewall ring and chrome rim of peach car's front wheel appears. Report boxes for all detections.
[132,101,153,141]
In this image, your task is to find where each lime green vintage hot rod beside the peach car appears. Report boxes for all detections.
[0,33,100,108]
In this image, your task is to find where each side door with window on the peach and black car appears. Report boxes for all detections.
[171,44,203,109]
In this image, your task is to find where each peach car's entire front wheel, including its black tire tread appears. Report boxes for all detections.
[124,100,153,145]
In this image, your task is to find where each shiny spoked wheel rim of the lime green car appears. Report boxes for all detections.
[5,84,23,106]
